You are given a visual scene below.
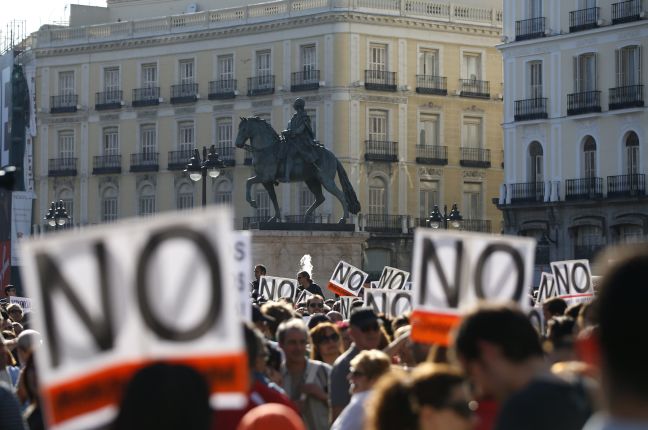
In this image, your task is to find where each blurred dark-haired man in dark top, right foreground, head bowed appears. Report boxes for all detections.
[454,306,591,430]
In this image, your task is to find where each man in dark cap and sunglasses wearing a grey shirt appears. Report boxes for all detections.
[330,307,380,422]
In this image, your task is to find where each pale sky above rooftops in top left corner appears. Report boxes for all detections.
[0,0,106,41]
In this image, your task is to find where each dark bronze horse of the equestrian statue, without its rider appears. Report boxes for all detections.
[235,117,360,224]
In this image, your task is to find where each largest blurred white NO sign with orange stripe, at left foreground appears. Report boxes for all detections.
[21,208,248,428]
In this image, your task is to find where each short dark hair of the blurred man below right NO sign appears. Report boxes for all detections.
[454,306,542,363]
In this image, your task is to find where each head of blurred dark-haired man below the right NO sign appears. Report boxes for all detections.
[454,306,543,399]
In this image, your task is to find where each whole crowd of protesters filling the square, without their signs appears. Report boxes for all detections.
[0,246,648,430]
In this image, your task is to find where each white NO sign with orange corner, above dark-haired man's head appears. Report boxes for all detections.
[411,232,535,345]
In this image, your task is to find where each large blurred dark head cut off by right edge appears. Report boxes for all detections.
[596,249,648,401]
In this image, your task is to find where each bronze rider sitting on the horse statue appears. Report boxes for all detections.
[281,98,320,182]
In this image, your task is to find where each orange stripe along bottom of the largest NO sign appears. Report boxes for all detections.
[43,354,248,424]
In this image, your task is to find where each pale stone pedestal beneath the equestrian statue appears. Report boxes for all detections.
[250,230,369,297]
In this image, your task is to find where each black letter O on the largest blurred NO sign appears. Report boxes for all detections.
[136,227,223,342]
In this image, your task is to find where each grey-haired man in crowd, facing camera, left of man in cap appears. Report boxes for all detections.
[277,318,331,430]
